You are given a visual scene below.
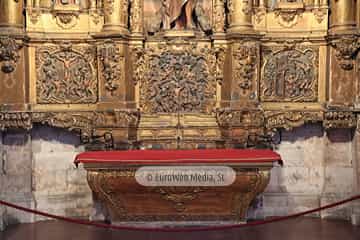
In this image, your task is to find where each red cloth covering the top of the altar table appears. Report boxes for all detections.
[74,149,282,165]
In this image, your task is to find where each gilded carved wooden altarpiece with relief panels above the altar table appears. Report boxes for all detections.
[0,0,360,148]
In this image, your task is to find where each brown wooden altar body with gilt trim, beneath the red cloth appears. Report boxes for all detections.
[77,150,280,225]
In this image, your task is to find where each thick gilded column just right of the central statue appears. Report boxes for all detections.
[228,0,254,34]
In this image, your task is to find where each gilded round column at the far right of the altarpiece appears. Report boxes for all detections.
[330,0,356,34]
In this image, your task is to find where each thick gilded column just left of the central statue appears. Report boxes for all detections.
[102,0,129,35]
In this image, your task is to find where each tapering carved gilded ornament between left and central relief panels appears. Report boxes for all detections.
[99,40,124,95]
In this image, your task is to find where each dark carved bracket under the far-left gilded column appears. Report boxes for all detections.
[0,36,22,73]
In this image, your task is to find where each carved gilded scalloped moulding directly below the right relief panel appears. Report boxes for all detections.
[265,111,323,132]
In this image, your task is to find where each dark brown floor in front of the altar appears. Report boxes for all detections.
[0,218,360,240]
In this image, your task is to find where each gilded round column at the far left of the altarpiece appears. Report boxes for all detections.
[0,0,24,32]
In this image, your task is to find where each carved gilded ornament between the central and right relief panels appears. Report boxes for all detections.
[232,43,260,100]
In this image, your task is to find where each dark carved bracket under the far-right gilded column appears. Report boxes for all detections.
[331,36,360,70]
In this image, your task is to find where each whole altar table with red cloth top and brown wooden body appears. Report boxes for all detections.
[75,149,281,222]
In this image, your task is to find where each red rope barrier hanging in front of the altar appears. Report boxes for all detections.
[0,195,360,232]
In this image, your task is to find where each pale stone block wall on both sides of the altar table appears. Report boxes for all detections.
[0,124,360,229]
